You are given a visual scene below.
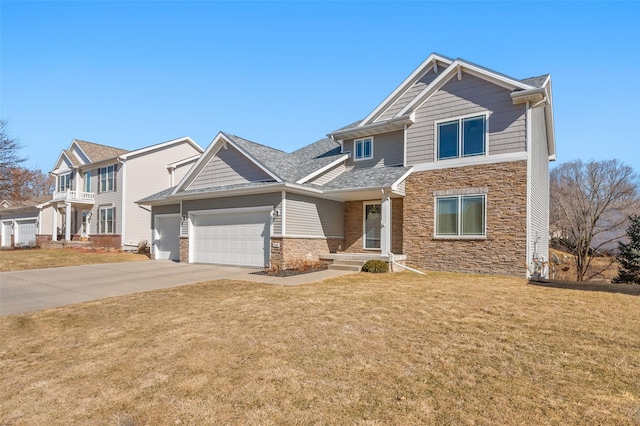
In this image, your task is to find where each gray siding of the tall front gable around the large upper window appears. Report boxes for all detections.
[406,73,526,166]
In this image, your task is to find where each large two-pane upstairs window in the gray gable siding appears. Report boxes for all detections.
[436,115,487,160]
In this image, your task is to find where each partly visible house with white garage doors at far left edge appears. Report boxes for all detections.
[0,195,51,247]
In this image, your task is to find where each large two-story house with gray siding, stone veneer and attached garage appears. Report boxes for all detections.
[139,54,555,276]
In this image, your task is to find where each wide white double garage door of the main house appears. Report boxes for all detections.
[191,210,270,268]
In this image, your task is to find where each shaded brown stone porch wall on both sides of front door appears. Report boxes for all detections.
[342,198,404,254]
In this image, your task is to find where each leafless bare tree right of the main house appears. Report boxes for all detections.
[550,160,640,281]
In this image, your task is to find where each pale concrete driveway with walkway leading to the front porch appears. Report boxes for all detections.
[0,261,352,316]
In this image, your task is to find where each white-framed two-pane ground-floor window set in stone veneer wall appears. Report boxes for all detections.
[436,195,487,237]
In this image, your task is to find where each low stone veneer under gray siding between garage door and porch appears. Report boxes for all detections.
[270,237,343,269]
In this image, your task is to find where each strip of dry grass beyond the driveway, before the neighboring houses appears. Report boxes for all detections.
[0,249,149,272]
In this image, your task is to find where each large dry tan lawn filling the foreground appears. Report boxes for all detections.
[0,273,640,425]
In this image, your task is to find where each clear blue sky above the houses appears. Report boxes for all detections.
[0,0,640,172]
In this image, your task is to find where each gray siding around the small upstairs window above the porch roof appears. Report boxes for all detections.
[344,130,404,168]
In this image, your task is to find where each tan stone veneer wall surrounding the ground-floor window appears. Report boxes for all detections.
[403,161,527,277]
